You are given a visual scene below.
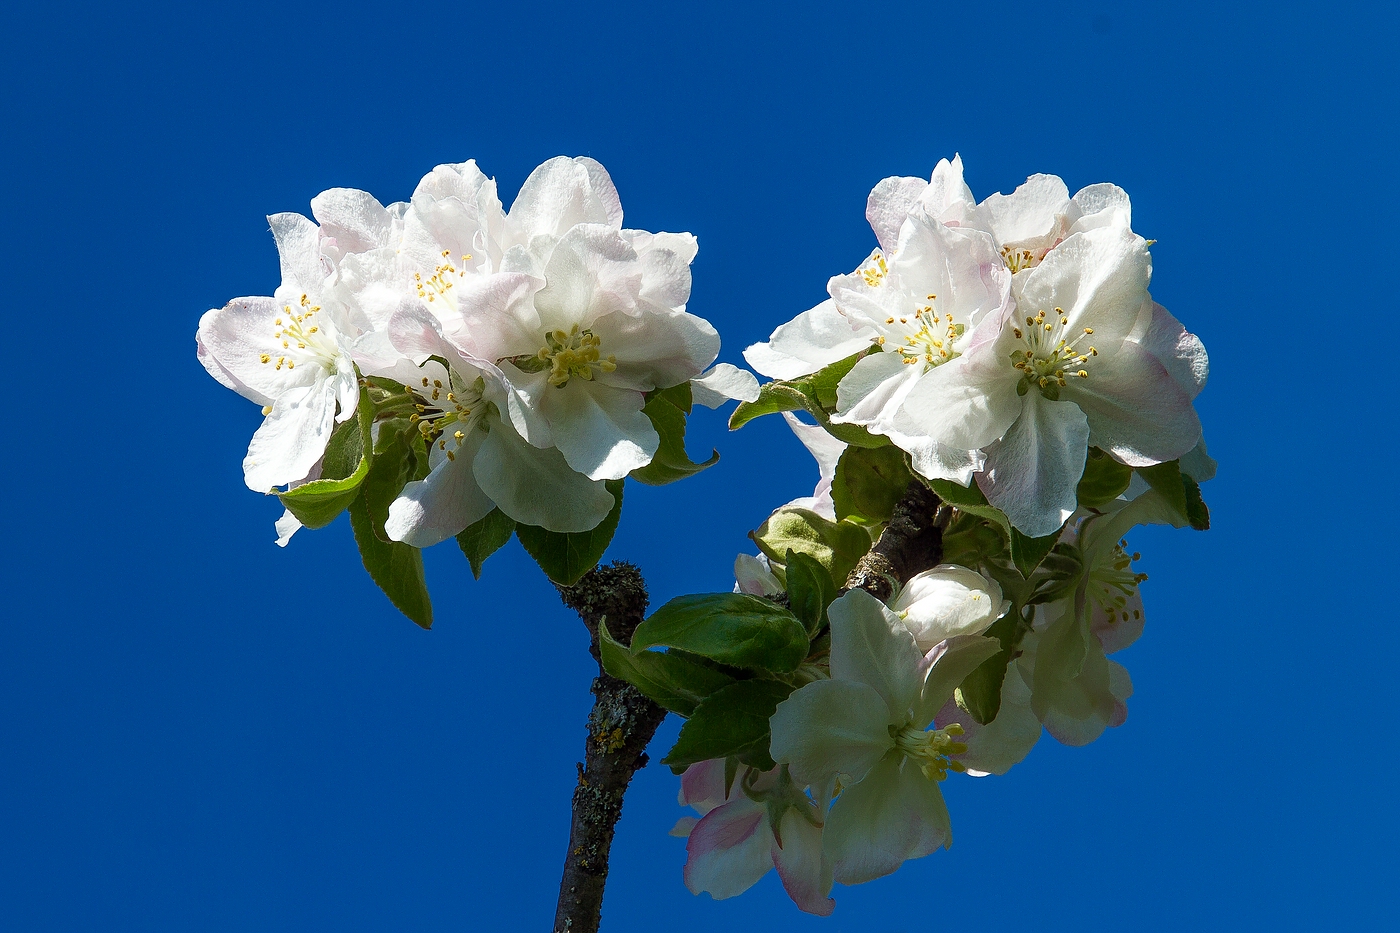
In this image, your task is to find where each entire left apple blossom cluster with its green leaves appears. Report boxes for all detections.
[196,157,757,625]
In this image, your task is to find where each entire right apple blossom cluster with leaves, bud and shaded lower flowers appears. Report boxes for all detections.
[603,158,1215,915]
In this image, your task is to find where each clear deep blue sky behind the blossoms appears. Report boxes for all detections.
[0,0,1400,933]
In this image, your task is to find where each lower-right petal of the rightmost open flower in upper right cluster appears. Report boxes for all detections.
[1061,334,1201,467]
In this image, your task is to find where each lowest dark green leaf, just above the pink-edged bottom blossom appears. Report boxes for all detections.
[662,679,792,770]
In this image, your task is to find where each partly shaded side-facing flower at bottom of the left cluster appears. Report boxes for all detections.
[377,311,615,548]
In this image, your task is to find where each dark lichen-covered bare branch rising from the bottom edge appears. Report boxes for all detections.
[554,560,666,933]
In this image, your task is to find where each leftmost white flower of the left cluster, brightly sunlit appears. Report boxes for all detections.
[196,208,360,492]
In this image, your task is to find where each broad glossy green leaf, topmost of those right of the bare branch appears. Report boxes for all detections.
[631,593,808,674]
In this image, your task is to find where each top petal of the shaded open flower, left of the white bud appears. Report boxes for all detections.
[827,590,928,714]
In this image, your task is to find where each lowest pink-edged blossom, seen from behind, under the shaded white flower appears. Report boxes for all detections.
[672,759,836,916]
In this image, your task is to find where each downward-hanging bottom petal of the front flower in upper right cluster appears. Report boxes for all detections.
[977,389,1089,538]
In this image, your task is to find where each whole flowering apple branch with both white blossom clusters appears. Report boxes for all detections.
[197,157,1215,913]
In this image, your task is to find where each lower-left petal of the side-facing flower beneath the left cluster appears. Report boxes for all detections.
[384,430,496,548]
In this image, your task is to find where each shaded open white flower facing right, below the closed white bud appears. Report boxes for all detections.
[771,590,998,884]
